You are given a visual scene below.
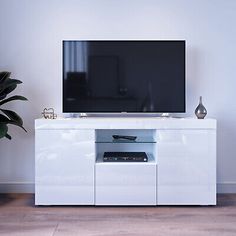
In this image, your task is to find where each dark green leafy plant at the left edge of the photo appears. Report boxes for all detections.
[0,71,27,139]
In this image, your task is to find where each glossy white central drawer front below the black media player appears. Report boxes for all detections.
[95,163,156,205]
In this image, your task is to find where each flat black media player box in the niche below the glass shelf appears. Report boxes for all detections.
[103,152,148,162]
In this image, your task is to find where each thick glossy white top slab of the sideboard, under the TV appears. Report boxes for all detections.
[35,117,216,129]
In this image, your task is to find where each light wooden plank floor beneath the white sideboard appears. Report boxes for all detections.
[0,194,236,236]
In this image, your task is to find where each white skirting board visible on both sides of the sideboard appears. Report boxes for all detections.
[0,182,236,193]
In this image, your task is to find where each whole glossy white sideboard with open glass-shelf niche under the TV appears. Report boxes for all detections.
[35,117,216,205]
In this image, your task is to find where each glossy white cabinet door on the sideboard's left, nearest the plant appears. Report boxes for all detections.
[35,130,95,205]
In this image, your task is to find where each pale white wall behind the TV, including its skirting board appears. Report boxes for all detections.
[0,0,236,192]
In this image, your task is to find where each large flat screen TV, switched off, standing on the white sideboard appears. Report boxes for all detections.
[63,40,185,113]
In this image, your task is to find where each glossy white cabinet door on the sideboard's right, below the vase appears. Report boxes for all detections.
[157,130,216,205]
